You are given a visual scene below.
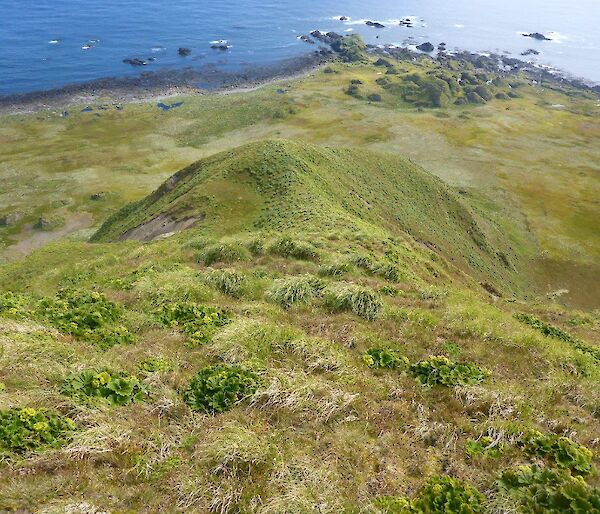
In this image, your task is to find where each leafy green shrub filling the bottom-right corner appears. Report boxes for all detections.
[496,466,600,514]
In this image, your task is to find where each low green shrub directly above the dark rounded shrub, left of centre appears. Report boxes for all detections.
[156,302,231,348]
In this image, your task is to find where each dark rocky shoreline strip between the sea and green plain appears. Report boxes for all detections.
[0,35,600,115]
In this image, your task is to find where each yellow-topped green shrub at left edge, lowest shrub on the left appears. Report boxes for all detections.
[0,407,75,453]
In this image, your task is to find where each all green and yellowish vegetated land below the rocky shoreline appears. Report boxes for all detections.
[0,38,600,514]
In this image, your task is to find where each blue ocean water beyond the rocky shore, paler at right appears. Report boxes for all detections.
[0,0,600,95]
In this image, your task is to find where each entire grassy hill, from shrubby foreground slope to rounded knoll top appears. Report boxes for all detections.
[0,141,600,514]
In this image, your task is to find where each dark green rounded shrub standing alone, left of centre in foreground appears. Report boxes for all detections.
[183,365,258,413]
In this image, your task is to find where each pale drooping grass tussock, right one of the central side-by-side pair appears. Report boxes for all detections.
[323,283,383,321]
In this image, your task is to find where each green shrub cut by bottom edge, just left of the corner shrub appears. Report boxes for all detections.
[411,477,486,514]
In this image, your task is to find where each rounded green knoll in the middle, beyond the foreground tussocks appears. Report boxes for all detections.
[92,141,518,287]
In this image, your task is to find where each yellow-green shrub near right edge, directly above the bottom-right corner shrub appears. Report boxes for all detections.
[519,430,594,475]
